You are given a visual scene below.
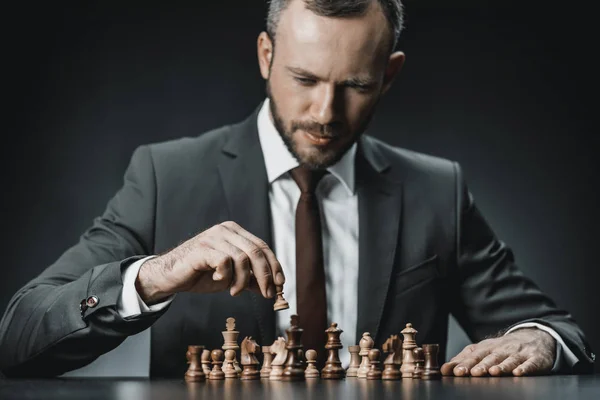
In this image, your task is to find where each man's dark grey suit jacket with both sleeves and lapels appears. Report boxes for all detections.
[0,104,593,377]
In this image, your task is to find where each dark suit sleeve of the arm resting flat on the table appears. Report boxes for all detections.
[451,164,594,373]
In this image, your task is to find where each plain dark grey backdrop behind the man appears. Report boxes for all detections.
[0,0,600,376]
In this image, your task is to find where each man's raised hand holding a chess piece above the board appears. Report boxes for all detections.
[135,221,285,305]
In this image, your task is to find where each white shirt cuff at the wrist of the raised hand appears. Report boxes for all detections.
[117,256,175,318]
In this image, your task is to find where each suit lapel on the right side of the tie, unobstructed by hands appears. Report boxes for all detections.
[356,136,402,340]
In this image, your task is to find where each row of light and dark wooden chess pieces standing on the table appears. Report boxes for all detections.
[185,315,441,382]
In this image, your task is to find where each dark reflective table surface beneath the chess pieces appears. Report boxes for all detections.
[0,375,600,400]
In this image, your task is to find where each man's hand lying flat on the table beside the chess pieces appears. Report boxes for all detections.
[441,328,556,376]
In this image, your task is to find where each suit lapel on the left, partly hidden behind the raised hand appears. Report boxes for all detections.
[218,104,275,343]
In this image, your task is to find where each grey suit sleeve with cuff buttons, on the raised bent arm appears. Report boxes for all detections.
[0,146,166,377]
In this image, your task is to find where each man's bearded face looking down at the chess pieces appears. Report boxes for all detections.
[263,0,391,169]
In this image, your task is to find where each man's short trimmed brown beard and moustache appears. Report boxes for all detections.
[266,80,379,170]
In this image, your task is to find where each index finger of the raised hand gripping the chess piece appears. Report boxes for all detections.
[223,226,276,298]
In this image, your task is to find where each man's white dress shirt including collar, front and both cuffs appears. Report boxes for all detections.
[117,99,577,370]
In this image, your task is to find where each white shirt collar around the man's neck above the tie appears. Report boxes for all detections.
[257,98,356,195]
